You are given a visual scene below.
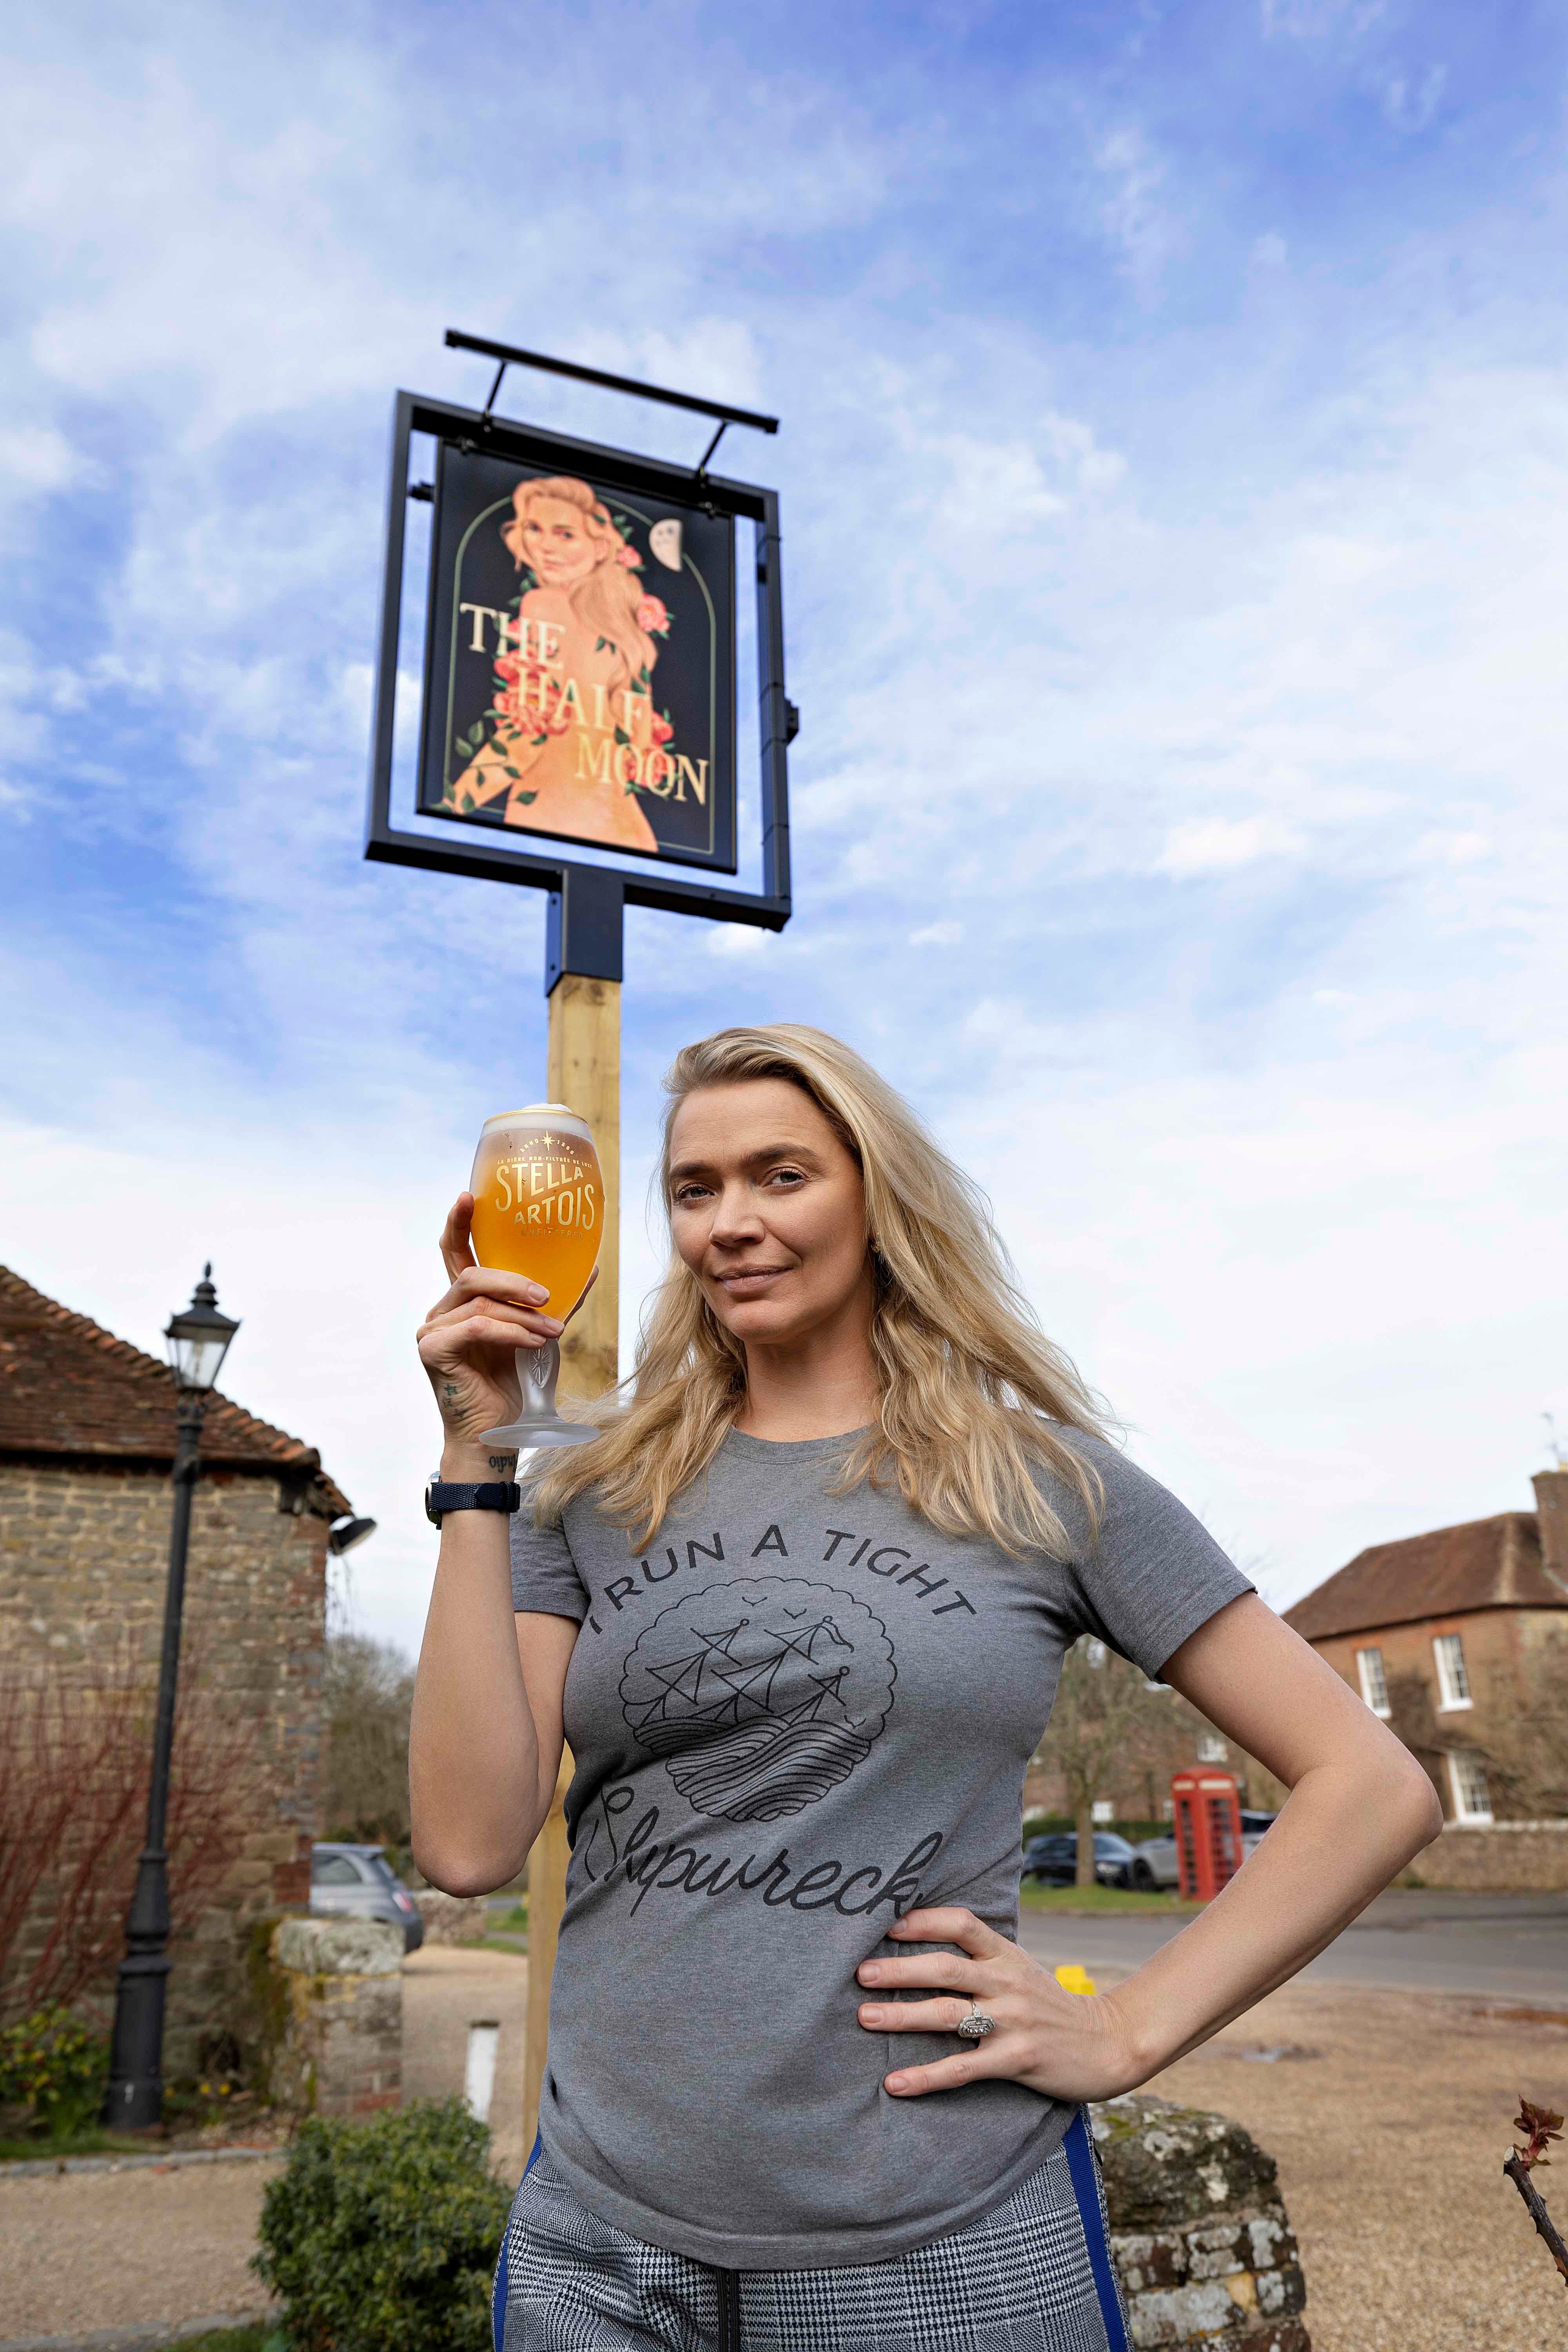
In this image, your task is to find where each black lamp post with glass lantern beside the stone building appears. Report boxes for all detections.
[103,1265,240,2131]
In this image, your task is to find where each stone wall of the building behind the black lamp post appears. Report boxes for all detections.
[0,1461,327,2079]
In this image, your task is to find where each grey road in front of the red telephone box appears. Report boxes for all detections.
[1020,1889,1568,2011]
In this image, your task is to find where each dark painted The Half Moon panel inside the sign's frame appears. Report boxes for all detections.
[418,435,736,873]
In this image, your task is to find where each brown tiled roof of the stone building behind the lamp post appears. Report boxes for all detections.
[0,1265,348,1517]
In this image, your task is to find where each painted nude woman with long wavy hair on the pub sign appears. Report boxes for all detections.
[451,475,670,854]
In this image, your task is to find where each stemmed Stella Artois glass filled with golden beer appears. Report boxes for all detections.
[468,1103,604,1451]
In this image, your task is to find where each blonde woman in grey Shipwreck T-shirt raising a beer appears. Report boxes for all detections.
[411,1025,1439,2352]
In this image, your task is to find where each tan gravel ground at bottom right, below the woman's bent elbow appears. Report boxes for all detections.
[1150,1985,1568,2352]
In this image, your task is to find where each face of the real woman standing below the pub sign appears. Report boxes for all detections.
[670,1077,870,1345]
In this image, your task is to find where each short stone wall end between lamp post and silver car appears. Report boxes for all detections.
[266,1919,402,2114]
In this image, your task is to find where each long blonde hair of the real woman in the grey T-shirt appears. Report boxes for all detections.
[534,1021,1105,1559]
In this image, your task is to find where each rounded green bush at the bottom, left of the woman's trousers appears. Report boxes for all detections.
[252,2098,508,2352]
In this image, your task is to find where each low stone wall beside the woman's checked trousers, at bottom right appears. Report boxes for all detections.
[1091,2093,1312,2352]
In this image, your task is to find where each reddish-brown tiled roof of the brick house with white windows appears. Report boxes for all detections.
[1286,1510,1568,1642]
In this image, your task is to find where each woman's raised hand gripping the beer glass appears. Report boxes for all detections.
[418,1192,564,1456]
